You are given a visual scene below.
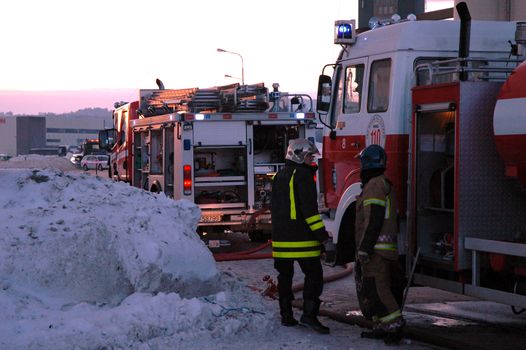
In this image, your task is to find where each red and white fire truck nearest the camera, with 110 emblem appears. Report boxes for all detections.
[317,8,526,308]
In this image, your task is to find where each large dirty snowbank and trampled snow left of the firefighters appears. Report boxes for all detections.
[0,157,438,350]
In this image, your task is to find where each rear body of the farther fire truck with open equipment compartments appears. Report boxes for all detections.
[132,112,316,229]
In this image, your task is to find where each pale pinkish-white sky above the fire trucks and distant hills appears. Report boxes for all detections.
[0,0,453,114]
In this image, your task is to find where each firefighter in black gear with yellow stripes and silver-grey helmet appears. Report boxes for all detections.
[271,139,336,334]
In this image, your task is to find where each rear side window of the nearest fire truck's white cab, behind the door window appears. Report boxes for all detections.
[367,59,391,113]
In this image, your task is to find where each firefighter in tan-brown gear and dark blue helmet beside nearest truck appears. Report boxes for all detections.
[355,145,405,343]
